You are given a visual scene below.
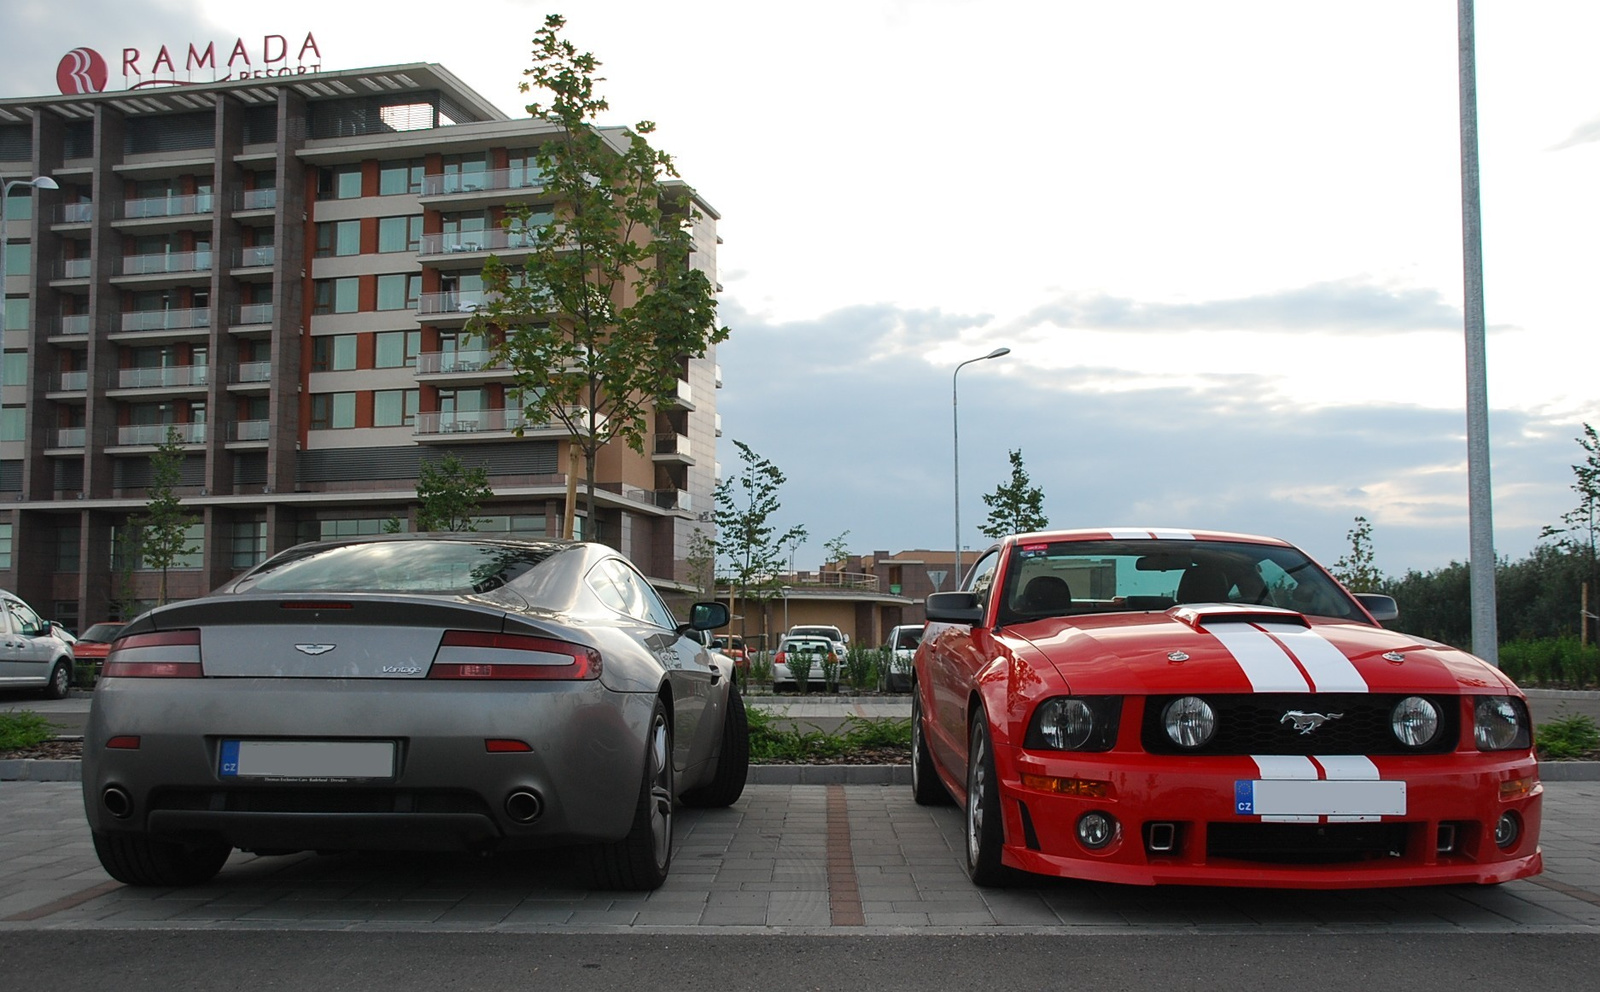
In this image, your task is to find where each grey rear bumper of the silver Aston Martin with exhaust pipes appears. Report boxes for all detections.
[83,678,654,851]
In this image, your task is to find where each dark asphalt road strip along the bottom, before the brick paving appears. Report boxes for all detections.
[3,931,1600,992]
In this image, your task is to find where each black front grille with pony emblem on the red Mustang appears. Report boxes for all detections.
[1141,693,1461,755]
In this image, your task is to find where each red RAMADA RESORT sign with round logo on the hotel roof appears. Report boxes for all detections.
[56,30,322,96]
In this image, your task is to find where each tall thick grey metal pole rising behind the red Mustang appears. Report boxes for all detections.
[1456,0,1499,667]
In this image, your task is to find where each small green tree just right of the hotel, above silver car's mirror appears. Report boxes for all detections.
[715,440,805,646]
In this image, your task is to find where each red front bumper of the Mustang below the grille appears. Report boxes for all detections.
[995,747,1542,888]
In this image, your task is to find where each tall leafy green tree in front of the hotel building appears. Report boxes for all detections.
[469,14,728,536]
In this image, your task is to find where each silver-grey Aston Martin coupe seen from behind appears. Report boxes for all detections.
[83,533,749,890]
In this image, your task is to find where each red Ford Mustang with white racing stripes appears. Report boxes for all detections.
[912,530,1544,888]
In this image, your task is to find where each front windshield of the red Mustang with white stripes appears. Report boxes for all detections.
[1000,541,1366,622]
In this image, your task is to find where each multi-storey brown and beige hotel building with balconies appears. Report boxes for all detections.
[0,64,720,626]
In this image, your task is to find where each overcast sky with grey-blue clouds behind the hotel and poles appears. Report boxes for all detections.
[0,0,1600,574]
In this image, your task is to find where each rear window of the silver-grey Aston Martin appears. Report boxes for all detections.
[234,541,554,595]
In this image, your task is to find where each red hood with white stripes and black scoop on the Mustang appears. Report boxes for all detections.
[997,606,1520,696]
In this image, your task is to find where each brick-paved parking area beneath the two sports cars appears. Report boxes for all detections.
[0,782,1600,933]
